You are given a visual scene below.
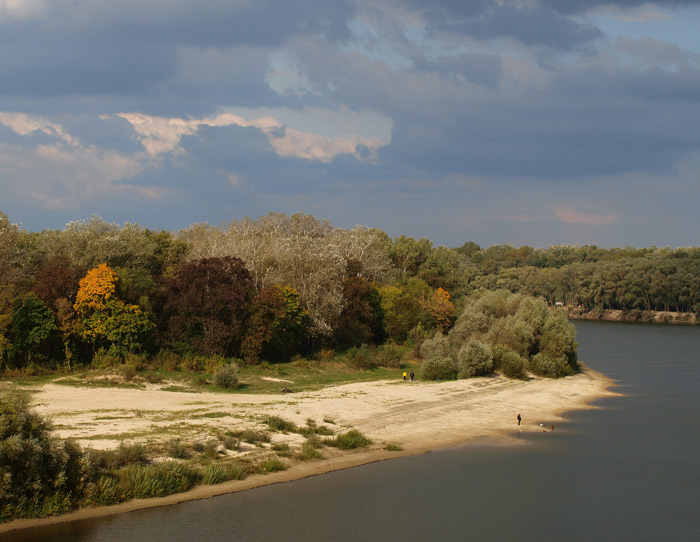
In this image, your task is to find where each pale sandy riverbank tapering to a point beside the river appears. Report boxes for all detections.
[0,369,614,532]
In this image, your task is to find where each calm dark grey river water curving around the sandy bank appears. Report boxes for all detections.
[5,322,700,542]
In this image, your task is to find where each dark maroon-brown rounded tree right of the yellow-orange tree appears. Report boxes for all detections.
[162,257,253,355]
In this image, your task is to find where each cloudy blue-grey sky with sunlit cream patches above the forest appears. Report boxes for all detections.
[0,0,700,247]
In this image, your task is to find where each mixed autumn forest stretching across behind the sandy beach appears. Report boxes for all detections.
[0,211,700,376]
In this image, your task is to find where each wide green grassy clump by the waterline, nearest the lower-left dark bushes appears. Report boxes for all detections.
[119,461,202,499]
